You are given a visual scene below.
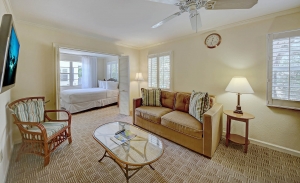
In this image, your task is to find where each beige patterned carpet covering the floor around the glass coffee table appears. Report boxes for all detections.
[7,106,300,183]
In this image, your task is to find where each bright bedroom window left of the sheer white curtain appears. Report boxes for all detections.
[60,61,82,86]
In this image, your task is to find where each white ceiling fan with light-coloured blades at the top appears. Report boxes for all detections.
[149,0,258,30]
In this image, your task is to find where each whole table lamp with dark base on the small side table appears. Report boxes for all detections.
[225,76,254,114]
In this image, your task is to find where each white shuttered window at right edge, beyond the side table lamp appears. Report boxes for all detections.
[267,30,300,109]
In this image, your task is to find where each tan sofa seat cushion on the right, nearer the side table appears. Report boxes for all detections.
[161,111,203,139]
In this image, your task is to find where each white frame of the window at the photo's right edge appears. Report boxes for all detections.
[266,29,300,110]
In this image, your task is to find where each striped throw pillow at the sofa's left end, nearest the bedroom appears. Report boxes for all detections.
[141,88,161,107]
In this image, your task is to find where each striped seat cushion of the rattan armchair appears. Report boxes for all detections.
[28,122,68,140]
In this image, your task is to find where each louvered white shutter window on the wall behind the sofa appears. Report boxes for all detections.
[148,52,172,90]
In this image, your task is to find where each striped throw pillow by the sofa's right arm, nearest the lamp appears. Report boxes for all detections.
[189,90,210,123]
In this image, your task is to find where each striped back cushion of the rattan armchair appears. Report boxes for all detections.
[14,100,44,122]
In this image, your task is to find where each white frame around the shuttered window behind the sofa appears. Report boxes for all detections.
[147,51,173,91]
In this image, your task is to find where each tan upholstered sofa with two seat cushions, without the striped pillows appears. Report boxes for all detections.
[133,91,223,158]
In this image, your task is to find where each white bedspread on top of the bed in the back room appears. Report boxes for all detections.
[60,88,119,104]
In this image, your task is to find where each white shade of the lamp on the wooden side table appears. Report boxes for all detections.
[225,76,254,93]
